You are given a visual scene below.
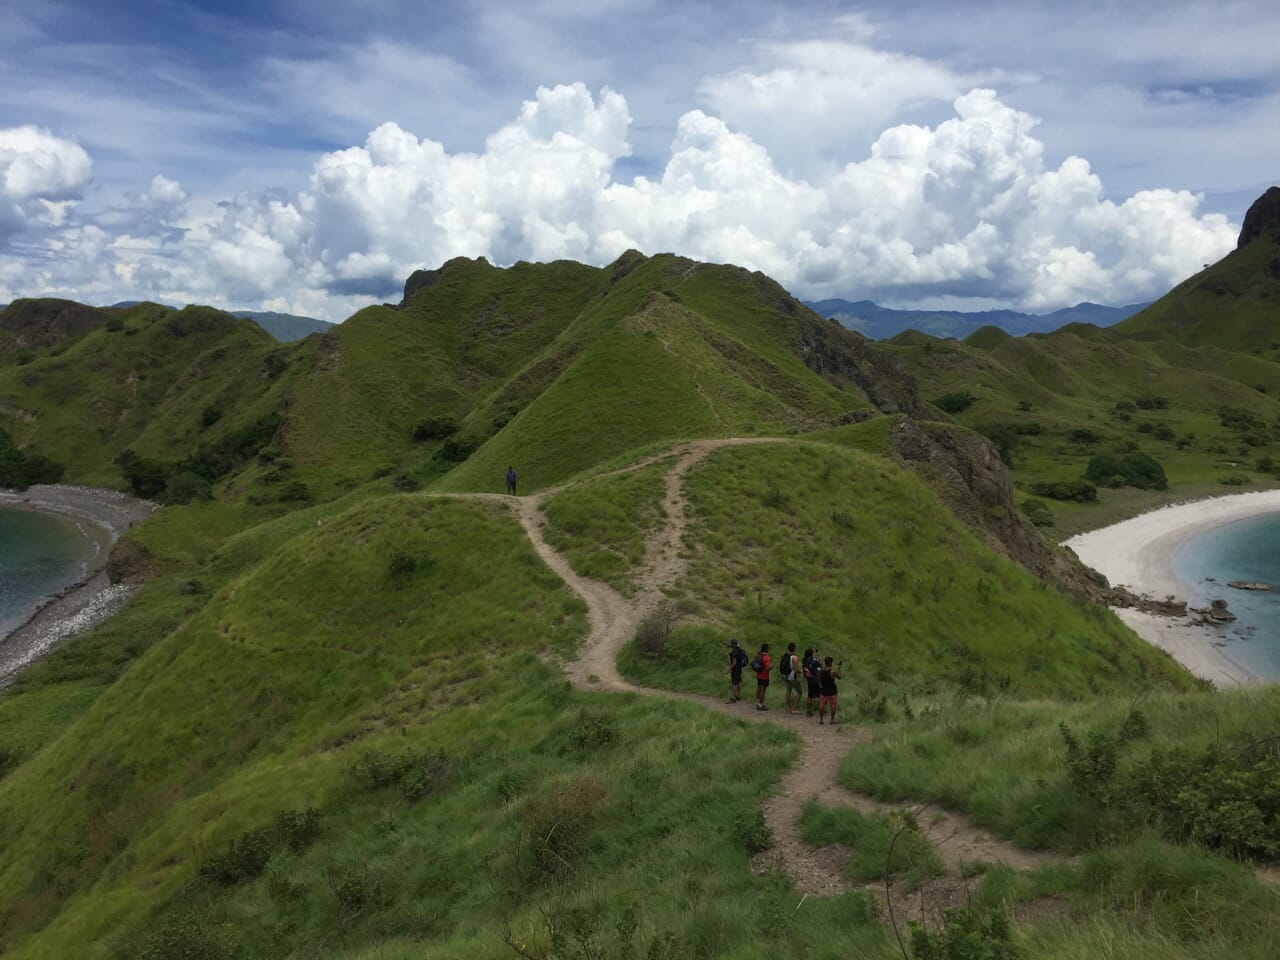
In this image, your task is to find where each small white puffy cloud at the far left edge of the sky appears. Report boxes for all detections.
[0,124,93,243]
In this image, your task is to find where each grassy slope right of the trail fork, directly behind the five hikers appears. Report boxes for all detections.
[627,443,1190,698]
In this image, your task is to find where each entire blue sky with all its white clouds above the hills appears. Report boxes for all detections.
[0,0,1280,321]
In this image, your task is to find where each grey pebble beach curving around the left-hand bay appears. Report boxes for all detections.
[0,484,159,690]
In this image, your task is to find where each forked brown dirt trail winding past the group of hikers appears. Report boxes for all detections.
[460,438,1053,916]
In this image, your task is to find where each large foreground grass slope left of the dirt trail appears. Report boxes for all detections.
[0,488,936,960]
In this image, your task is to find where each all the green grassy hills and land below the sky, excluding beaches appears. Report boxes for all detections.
[0,191,1280,960]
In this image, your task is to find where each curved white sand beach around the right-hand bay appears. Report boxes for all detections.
[1062,490,1280,687]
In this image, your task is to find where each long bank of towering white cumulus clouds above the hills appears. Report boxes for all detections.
[0,80,1235,320]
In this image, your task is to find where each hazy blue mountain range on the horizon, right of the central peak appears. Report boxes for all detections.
[805,300,1151,340]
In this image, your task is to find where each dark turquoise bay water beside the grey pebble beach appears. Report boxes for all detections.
[0,507,95,639]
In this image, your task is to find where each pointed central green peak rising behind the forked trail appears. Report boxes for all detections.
[438,256,868,490]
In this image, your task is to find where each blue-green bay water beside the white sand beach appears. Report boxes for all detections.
[1172,513,1280,680]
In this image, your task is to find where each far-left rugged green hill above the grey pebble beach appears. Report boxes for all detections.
[0,303,276,486]
